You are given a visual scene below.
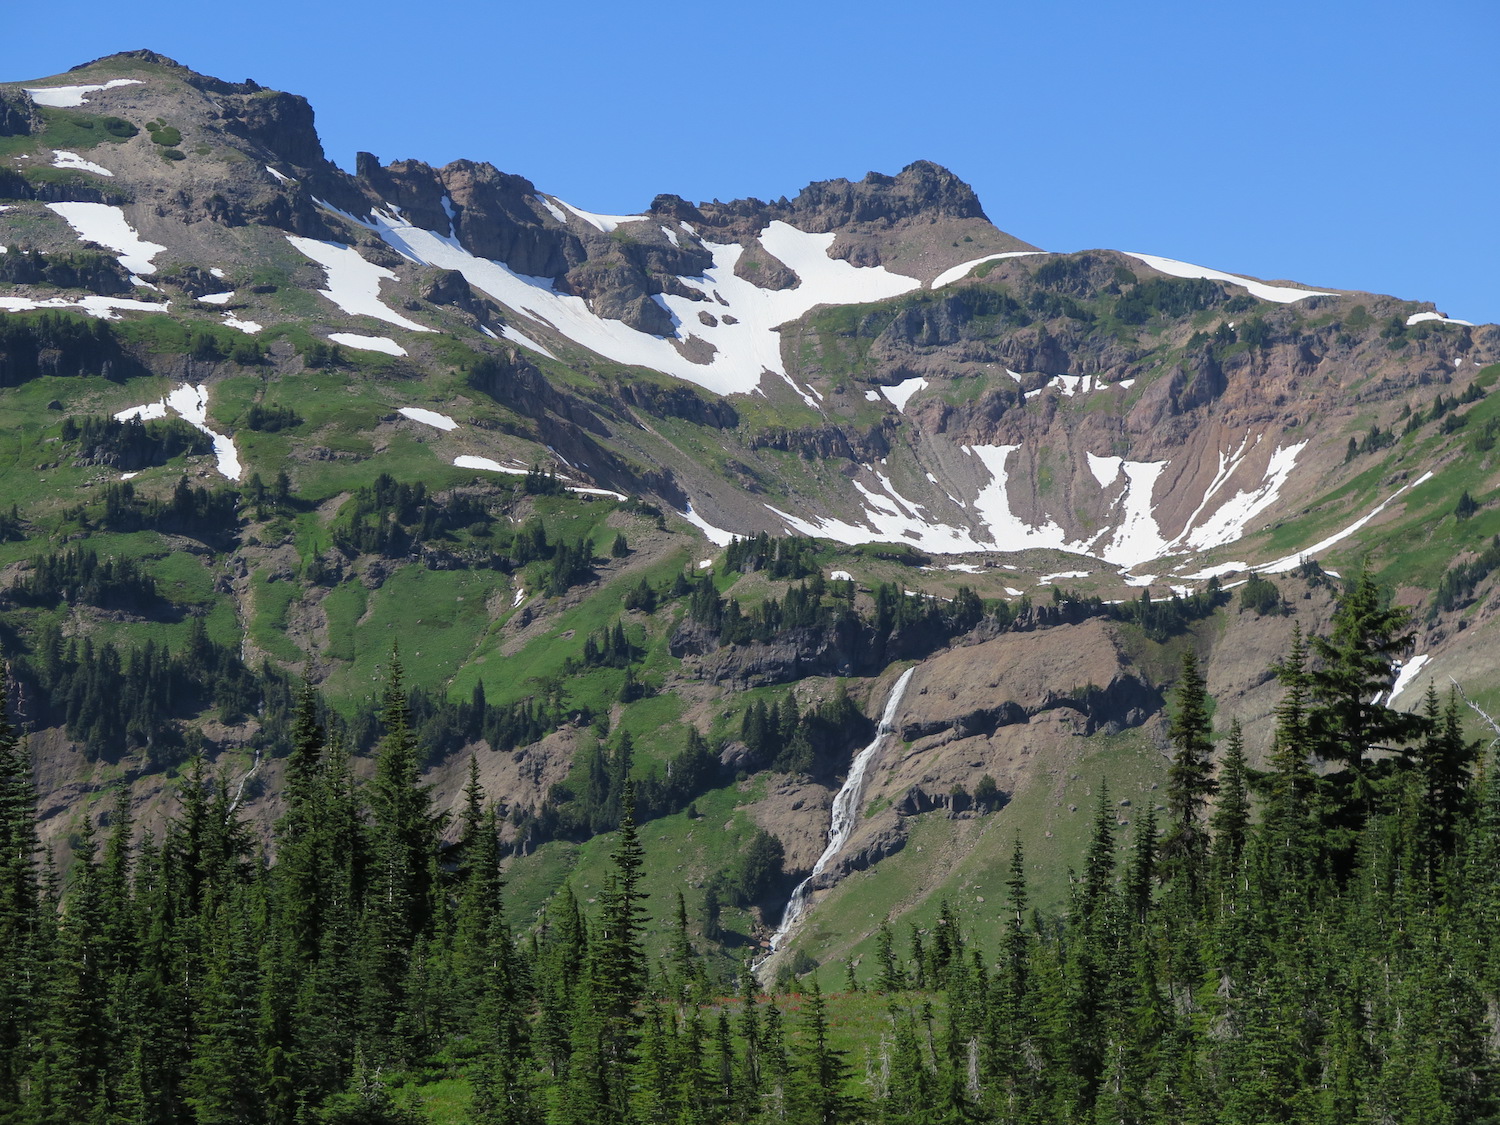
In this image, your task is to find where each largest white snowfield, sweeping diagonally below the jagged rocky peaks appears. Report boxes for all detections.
[314,212,921,395]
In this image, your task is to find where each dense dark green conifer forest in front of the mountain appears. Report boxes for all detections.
[0,573,1500,1125]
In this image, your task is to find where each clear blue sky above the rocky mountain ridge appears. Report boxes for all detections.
[0,0,1500,321]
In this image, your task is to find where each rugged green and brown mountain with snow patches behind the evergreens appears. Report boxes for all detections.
[0,51,1500,978]
